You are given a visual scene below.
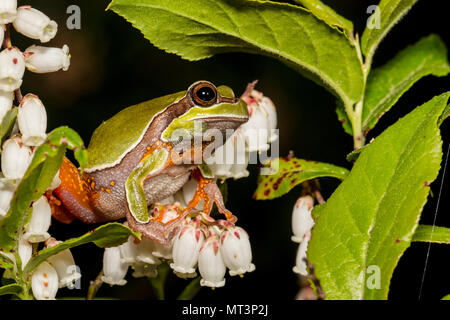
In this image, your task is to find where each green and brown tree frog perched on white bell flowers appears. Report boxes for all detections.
[59,81,248,243]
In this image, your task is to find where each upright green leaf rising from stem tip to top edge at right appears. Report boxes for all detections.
[361,0,417,65]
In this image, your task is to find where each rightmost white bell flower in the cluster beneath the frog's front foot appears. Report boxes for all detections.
[220,227,255,276]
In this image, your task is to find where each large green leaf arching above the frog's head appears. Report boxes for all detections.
[108,0,363,105]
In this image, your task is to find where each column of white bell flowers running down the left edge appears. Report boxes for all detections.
[0,0,73,299]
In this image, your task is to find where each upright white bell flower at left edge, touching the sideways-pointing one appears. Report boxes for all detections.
[0,47,25,92]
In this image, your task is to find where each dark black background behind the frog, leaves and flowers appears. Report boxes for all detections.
[8,0,450,301]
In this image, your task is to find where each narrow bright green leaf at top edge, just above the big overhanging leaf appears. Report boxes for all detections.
[294,0,353,38]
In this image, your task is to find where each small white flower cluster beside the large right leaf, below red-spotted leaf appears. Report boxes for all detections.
[291,196,314,276]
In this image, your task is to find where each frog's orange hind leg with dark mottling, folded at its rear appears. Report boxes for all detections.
[45,157,105,223]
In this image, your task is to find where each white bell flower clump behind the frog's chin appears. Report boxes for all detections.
[206,89,278,179]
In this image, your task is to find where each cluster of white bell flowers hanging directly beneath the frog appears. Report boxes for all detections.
[102,180,255,288]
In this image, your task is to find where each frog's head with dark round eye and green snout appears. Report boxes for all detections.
[161,81,248,142]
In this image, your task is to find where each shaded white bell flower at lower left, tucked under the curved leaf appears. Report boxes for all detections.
[45,238,81,288]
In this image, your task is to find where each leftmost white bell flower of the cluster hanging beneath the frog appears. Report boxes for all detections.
[102,247,129,286]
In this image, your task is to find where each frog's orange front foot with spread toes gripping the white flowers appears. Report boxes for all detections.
[184,169,237,223]
